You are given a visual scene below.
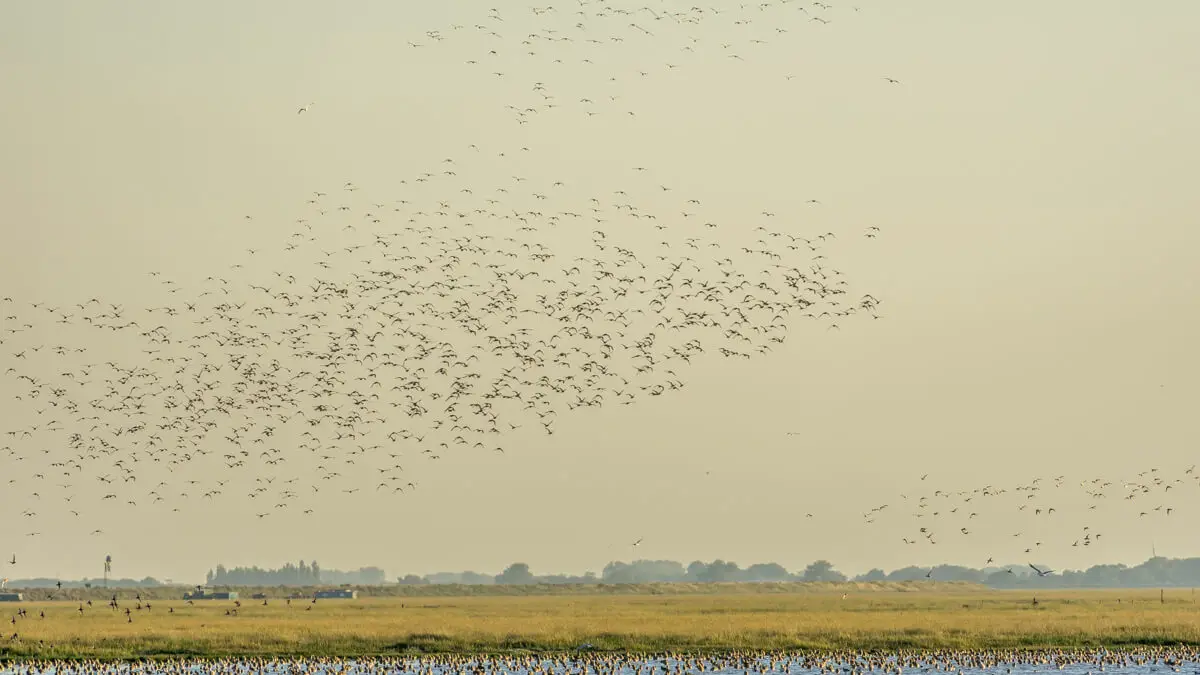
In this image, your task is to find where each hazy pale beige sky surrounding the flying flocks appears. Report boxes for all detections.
[0,0,1200,580]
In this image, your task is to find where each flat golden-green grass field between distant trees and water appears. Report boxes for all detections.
[0,584,1200,658]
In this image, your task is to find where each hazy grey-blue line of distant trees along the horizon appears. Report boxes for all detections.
[8,556,1200,589]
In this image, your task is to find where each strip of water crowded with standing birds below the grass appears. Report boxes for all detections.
[0,645,1200,675]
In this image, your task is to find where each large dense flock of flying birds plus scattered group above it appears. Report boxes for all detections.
[0,0,888,562]
